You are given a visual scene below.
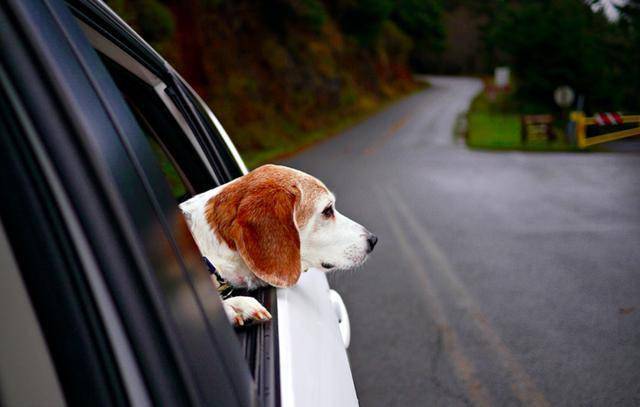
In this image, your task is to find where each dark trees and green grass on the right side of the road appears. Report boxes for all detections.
[462,0,640,151]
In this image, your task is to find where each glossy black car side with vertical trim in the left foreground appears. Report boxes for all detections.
[0,1,256,405]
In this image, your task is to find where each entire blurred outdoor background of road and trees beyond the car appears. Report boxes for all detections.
[107,0,640,406]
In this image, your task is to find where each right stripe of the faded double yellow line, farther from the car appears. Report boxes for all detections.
[387,188,549,406]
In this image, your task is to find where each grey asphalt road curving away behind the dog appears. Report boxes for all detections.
[285,77,640,407]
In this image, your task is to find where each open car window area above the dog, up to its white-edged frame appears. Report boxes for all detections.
[78,20,246,198]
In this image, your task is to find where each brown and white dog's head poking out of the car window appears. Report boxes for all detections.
[205,165,377,287]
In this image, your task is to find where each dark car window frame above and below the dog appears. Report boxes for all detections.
[67,0,280,406]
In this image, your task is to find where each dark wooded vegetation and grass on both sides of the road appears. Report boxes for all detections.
[107,0,640,162]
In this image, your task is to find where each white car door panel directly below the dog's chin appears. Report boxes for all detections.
[278,270,358,407]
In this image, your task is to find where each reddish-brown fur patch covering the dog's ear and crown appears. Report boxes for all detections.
[205,165,328,287]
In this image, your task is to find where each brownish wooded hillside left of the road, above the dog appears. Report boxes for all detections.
[108,0,430,165]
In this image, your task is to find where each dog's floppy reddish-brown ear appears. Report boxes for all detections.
[234,183,302,287]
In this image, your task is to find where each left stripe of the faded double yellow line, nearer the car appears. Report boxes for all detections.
[376,190,493,406]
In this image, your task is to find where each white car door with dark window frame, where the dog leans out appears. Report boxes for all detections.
[62,1,357,406]
